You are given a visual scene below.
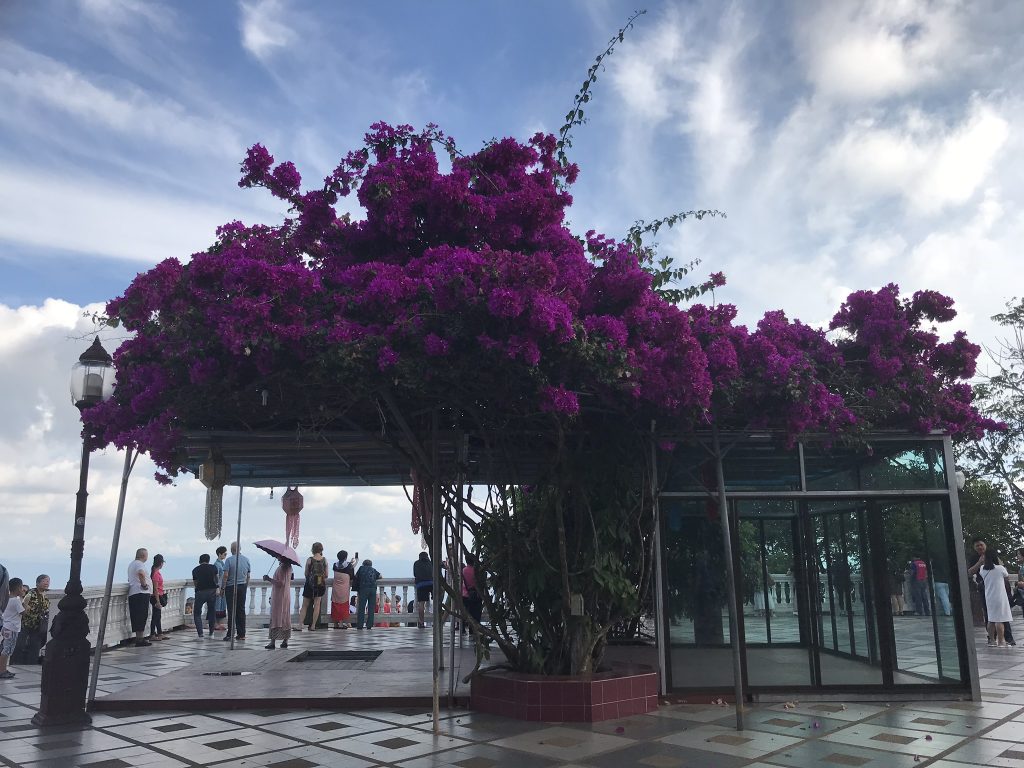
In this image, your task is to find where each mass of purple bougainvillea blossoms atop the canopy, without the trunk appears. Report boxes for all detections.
[85,123,992,475]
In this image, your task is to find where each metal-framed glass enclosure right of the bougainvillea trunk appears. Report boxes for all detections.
[659,437,970,692]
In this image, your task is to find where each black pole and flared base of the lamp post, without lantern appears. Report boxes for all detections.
[32,429,92,727]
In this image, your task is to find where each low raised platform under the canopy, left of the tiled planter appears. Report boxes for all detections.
[92,628,475,712]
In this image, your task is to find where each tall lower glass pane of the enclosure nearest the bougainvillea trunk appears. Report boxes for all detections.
[660,498,732,688]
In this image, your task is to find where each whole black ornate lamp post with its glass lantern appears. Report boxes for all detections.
[32,336,114,726]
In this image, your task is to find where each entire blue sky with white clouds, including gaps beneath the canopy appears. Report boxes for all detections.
[0,0,1024,583]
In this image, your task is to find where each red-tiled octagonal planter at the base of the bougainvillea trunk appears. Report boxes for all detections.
[470,665,657,723]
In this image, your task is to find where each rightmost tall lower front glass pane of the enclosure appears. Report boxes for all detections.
[879,501,962,685]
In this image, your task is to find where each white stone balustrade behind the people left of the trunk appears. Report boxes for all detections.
[46,579,416,647]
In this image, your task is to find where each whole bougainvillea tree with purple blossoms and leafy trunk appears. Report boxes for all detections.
[84,118,989,674]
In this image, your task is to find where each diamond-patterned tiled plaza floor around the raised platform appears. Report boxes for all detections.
[6,632,1024,768]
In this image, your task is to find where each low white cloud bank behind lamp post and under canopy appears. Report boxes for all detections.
[0,299,420,584]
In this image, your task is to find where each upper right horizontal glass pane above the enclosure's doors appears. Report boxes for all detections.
[804,440,946,490]
